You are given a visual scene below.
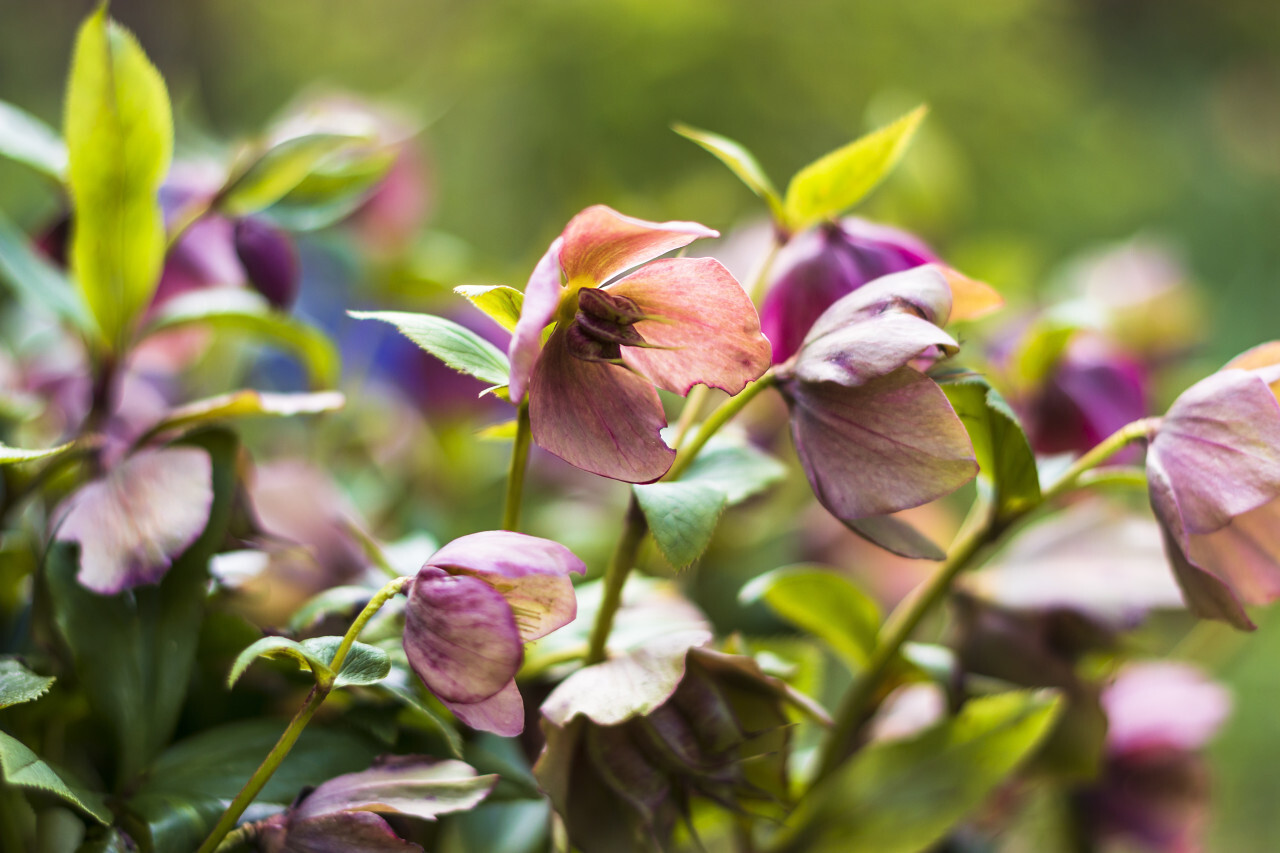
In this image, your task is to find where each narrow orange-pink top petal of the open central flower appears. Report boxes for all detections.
[561,205,719,284]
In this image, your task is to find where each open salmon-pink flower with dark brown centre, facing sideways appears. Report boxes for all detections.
[509,205,769,483]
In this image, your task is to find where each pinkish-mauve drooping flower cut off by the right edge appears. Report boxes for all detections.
[1147,343,1280,630]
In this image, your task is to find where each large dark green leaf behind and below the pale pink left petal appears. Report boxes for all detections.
[46,429,237,781]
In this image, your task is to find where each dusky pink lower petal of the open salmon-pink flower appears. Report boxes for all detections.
[529,329,676,483]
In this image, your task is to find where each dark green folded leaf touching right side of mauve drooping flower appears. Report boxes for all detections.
[942,375,1041,520]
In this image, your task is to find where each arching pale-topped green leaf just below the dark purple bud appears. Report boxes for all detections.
[143,287,342,388]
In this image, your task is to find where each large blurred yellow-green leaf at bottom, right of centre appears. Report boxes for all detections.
[785,692,1061,853]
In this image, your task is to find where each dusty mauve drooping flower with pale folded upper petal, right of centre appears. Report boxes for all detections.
[777,266,978,558]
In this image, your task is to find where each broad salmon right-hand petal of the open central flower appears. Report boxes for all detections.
[607,257,769,394]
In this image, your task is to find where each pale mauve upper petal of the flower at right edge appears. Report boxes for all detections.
[1147,370,1280,535]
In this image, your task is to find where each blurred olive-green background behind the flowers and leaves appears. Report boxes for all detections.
[0,0,1280,852]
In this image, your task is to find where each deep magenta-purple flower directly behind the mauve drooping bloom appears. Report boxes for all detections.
[760,216,938,364]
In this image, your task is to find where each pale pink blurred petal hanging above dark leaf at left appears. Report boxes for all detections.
[58,447,214,596]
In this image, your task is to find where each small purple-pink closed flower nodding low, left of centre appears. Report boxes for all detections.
[404,530,586,736]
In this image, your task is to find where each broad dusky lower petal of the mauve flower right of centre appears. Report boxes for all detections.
[783,368,978,519]
